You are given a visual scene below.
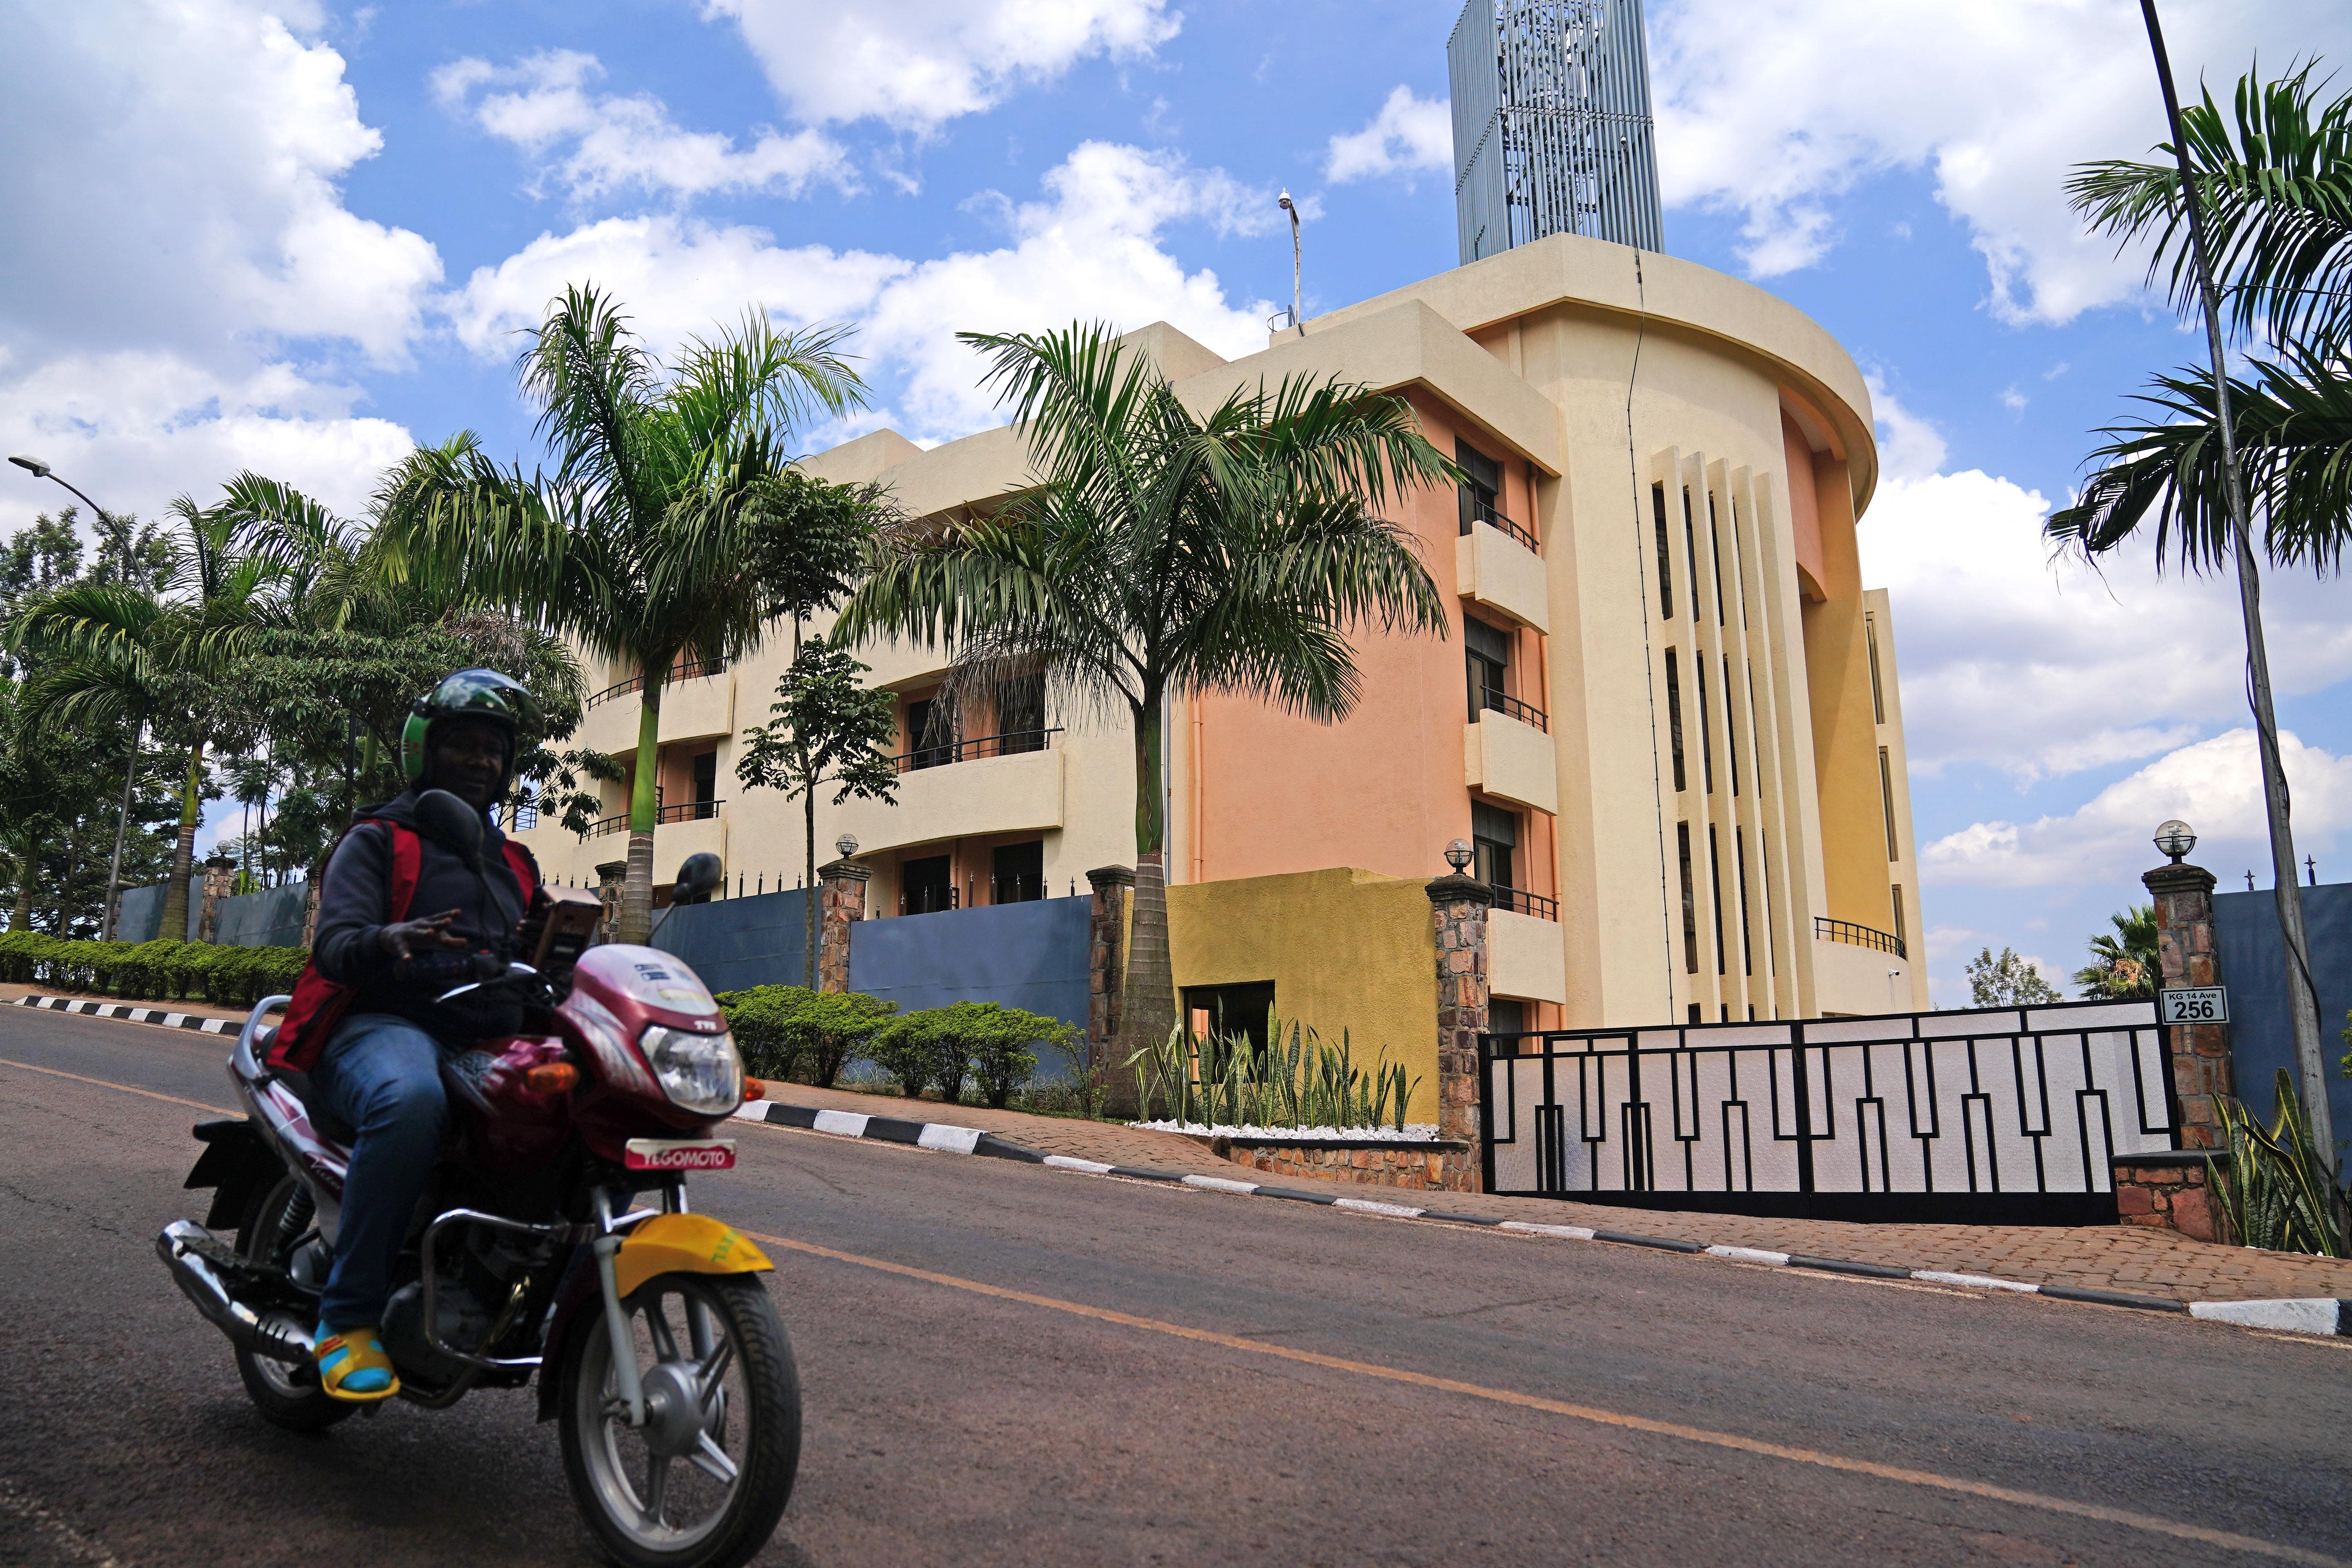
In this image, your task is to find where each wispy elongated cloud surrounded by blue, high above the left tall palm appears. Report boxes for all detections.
[433,49,856,200]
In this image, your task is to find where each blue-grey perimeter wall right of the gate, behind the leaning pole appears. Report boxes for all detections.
[2213,882,2352,1166]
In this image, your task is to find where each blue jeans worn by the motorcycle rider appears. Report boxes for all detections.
[310,1013,449,1328]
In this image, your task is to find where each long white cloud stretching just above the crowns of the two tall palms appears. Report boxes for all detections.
[449,141,1279,439]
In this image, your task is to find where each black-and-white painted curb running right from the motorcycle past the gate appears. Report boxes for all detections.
[736,1100,2352,1335]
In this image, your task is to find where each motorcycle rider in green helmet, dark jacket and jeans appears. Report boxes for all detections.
[270,670,539,1403]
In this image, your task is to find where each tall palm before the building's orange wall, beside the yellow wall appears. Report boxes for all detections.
[835,325,1456,1086]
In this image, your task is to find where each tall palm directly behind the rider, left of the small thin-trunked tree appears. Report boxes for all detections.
[376,287,866,940]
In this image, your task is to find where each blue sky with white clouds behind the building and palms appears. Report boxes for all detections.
[0,0,2352,1002]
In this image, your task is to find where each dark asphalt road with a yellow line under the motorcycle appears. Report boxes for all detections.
[0,1009,2352,1568]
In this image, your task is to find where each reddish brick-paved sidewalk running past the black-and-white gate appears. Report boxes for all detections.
[774,1084,2352,1302]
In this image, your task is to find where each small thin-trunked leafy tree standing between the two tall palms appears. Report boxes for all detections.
[736,637,898,990]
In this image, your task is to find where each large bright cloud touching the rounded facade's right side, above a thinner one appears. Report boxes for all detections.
[1860,463,2352,783]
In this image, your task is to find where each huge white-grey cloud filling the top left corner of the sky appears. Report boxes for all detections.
[0,0,440,536]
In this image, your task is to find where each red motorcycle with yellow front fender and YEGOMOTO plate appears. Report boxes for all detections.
[155,802,800,1568]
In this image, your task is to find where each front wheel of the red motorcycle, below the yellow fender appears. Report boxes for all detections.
[557,1274,800,1568]
